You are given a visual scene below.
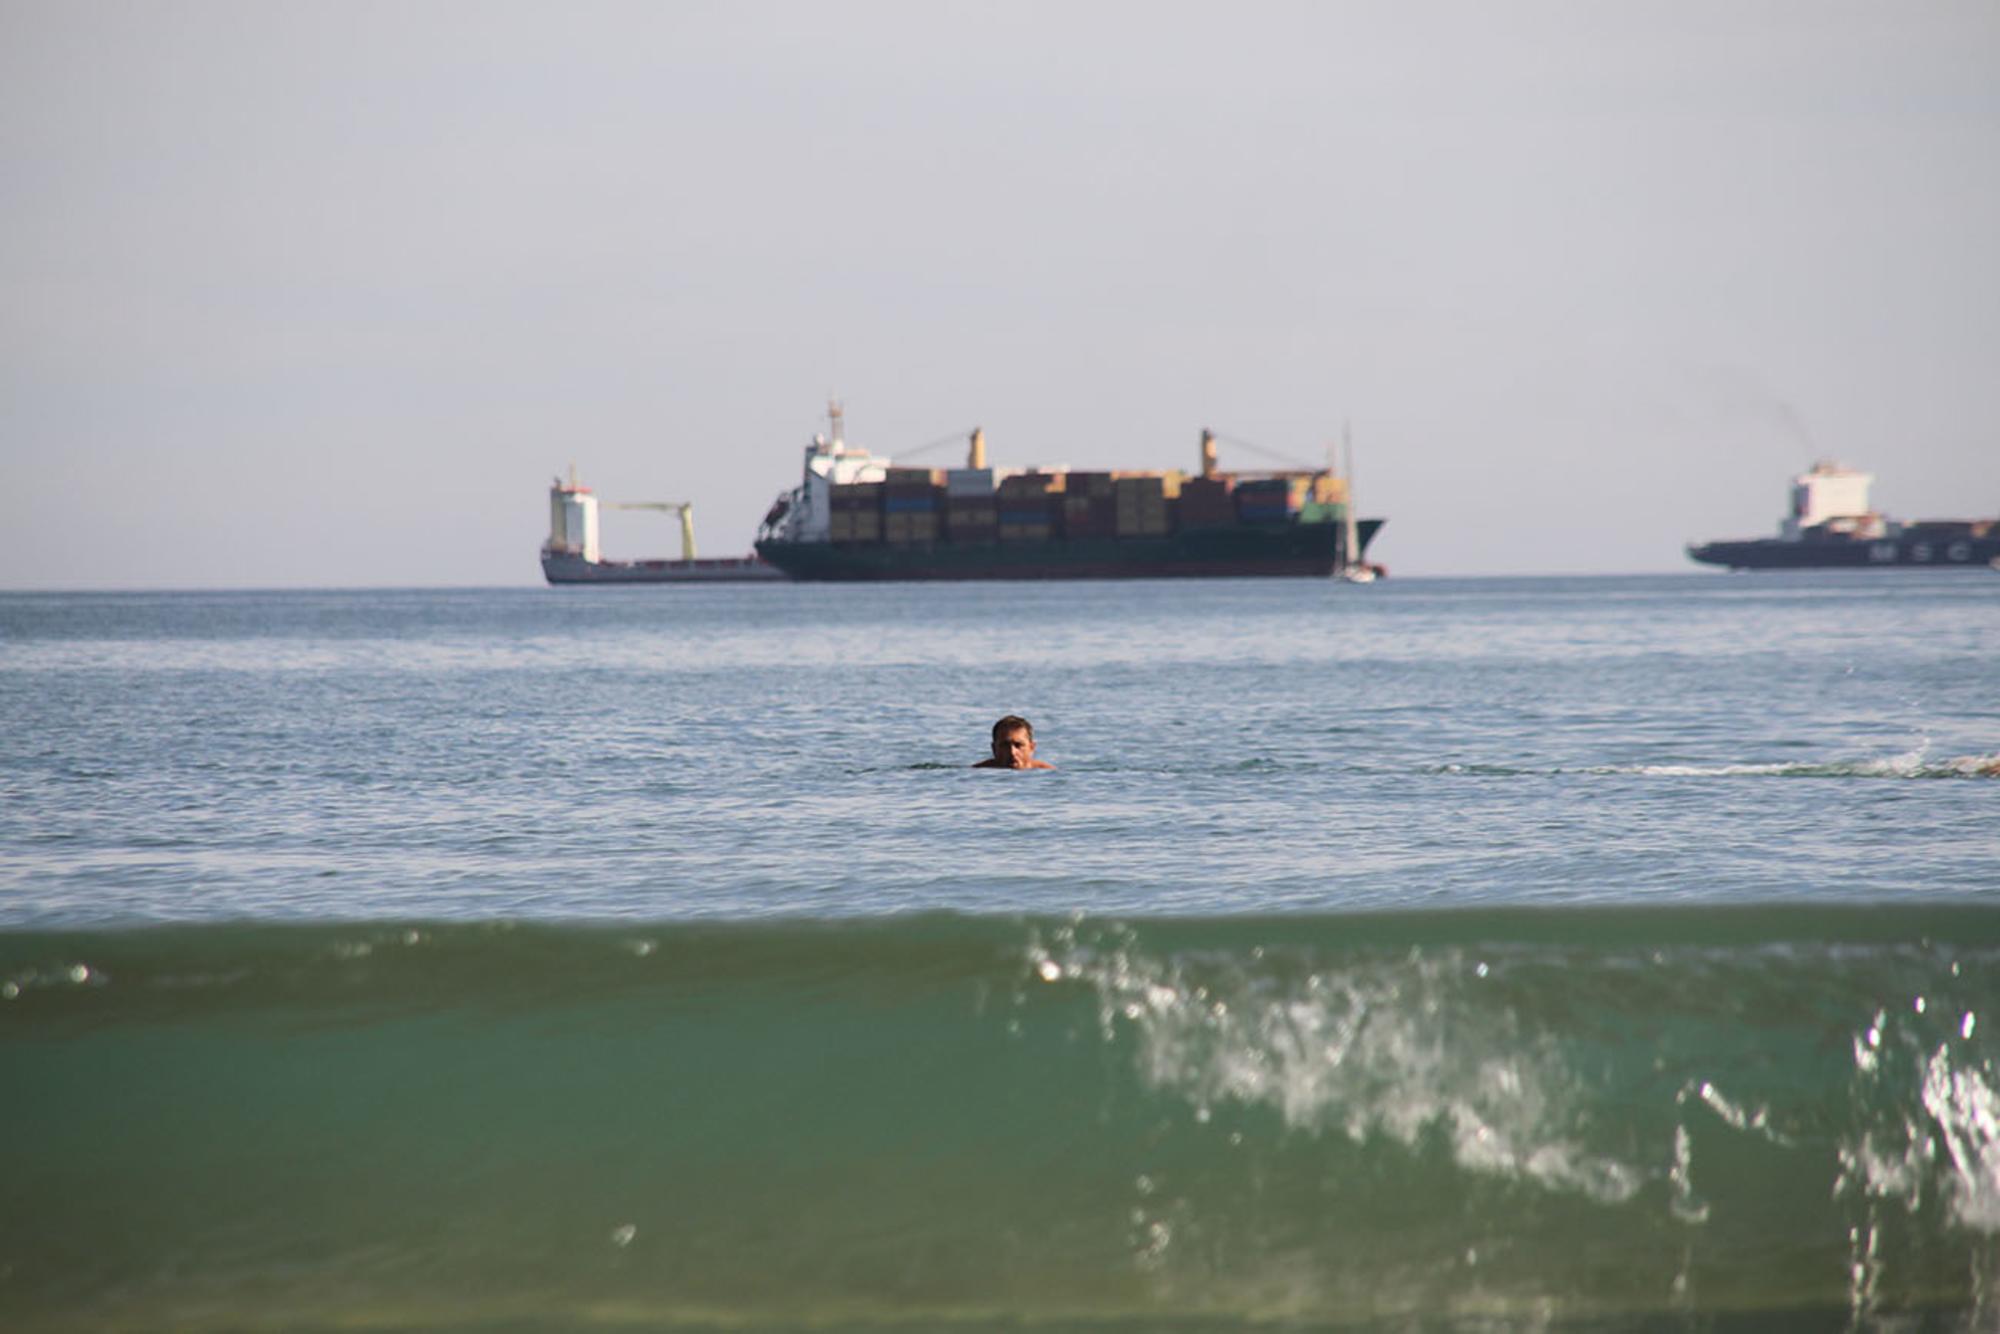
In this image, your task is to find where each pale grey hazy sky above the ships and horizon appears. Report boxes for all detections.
[0,0,2000,588]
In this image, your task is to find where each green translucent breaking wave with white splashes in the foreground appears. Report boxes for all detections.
[0,908,2000,1330]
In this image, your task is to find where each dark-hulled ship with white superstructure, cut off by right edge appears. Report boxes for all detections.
[1688,462,2000,570]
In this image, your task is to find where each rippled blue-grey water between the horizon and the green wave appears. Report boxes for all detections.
[0,572,2000,926]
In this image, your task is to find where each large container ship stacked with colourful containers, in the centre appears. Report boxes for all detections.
[756,402,1384,580]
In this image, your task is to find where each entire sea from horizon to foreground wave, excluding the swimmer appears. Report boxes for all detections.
[0,570,2000,1332]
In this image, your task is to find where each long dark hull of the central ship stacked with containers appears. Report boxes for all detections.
[756,518,1382,582]
